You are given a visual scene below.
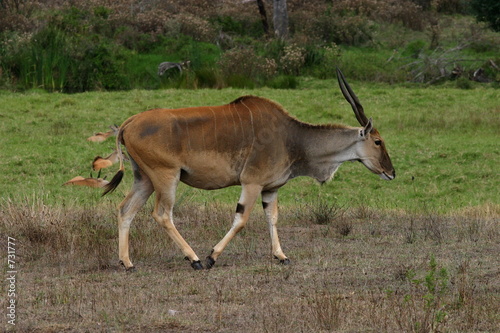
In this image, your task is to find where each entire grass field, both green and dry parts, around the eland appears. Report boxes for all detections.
[0,80,500,332]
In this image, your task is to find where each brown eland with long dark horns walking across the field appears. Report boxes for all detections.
[103,69,396,270]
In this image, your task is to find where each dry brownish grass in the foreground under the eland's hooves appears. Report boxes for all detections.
[0,200,500,332]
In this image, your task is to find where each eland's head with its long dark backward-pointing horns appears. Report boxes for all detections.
[337,68,396,180]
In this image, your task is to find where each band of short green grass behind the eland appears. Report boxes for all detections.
[0,80,500,213]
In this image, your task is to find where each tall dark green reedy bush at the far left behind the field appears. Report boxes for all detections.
[2,26,130,92]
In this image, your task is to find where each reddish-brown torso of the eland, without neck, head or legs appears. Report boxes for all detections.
[121,96,297,189]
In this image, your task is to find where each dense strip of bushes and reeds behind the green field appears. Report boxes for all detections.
[0,0,500,92]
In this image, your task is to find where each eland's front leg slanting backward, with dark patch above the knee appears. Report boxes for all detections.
[206,185,262,268]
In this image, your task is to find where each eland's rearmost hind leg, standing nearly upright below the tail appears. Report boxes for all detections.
[118,159,153,270]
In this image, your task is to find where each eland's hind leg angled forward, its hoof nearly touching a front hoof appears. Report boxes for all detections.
[153,171,203,269]
